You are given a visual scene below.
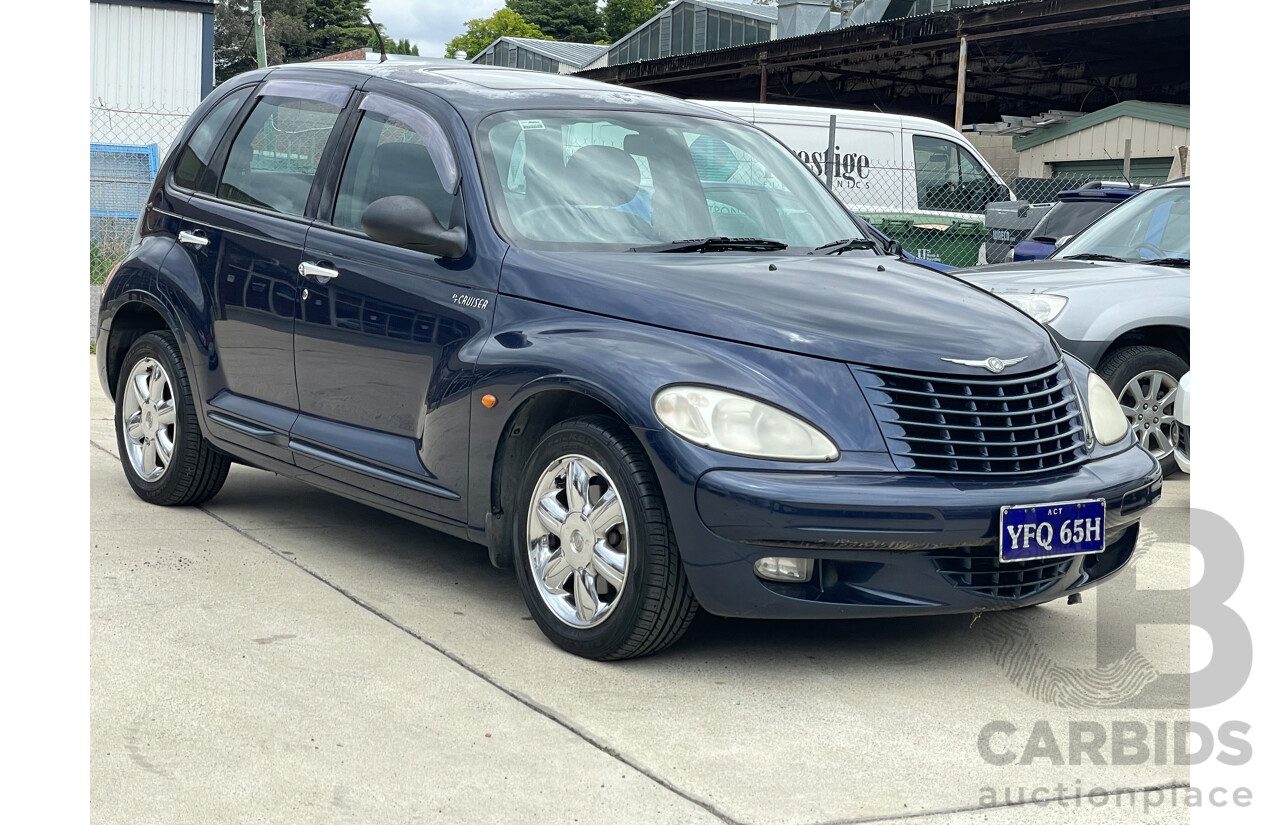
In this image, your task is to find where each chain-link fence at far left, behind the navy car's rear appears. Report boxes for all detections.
[88,104,191,285]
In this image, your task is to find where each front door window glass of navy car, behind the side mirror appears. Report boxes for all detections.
[333,100,458,232]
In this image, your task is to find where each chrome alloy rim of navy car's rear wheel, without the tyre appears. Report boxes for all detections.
[120,358,177,482]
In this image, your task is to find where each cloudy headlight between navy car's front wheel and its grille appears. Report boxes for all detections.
[653,386,840,462]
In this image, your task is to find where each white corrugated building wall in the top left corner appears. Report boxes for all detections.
[90,3,205,149]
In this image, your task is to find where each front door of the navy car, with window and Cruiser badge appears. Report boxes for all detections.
[292,81,497,523]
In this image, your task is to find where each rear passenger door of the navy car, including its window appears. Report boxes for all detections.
[182,81,352,460]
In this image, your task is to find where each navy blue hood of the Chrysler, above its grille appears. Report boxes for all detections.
[499,248,1060,375]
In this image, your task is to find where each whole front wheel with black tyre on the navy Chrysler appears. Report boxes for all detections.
[515,416,698,660]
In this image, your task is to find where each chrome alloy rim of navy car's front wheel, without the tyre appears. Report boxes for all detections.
[527,455,628,628]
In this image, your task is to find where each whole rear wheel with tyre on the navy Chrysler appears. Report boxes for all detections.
[115,331,230,505]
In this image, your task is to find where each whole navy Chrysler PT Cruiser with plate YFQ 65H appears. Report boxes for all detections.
[97,61,1161,659]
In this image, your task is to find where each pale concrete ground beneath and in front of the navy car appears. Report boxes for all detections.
[90,355,1190,825]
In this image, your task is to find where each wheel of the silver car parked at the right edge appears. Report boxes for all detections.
[1098,347,1190,473]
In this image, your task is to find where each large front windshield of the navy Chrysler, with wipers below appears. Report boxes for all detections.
[476,111,865,253]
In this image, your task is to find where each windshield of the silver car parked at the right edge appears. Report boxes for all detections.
[1050,185,1192,262]
